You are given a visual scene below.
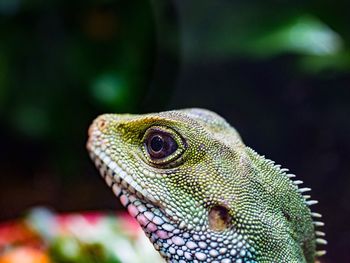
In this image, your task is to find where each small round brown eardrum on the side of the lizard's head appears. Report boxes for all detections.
[208,205,232,231]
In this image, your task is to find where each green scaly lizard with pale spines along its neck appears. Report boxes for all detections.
[87,108,327,263]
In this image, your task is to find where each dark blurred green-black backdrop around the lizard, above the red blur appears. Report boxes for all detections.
[0,0,350,262]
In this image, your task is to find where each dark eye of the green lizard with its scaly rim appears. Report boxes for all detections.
[144,126,184,165]
